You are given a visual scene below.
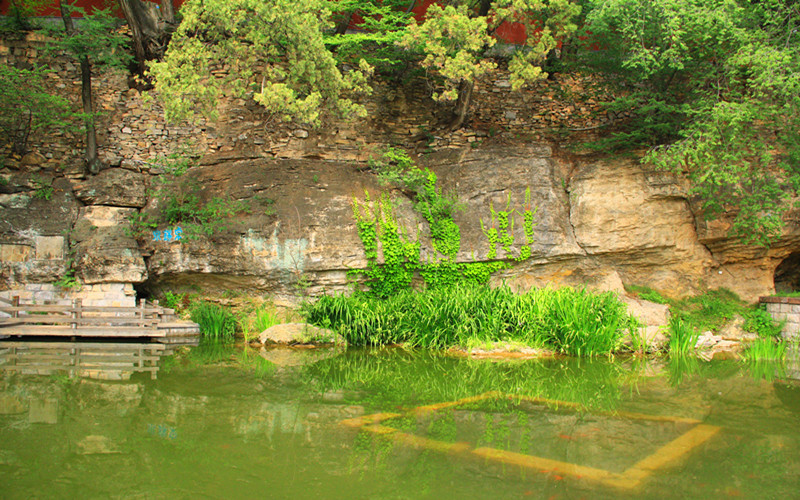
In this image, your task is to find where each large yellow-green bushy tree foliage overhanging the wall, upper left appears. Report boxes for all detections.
[149,0,372,125]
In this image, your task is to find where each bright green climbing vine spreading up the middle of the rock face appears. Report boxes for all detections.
[353,148,536,297]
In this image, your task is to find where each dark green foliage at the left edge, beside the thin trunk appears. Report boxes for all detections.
[0,64,72,155]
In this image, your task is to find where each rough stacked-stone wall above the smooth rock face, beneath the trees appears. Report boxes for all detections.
[0,32,617,168]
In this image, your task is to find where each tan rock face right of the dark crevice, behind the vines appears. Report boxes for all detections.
[125,145,798,300]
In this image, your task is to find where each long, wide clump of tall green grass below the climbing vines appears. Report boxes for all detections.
[304,284,637,356]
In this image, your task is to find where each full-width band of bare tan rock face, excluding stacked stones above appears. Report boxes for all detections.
[0,144,800,302]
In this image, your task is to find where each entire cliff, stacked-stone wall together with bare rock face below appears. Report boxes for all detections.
[0,34,800,300]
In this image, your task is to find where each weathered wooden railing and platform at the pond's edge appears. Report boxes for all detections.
[0,296,174,337]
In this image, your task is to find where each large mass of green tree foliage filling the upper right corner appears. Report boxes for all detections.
[586,0,800,246]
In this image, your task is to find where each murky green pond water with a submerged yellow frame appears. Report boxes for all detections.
[0,347,800,499]
